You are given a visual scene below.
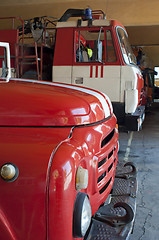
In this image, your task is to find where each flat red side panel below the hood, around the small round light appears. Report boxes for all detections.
[0,127,70,240]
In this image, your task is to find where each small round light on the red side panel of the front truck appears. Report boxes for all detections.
[0,163,19,182]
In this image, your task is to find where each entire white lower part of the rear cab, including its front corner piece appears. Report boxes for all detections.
[53,65,141,113]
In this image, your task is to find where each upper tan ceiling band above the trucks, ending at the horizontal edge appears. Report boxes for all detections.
[0,0,159,25]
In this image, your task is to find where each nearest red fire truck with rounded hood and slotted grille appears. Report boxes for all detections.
[0,42,137,240]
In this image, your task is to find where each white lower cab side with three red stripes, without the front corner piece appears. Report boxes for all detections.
[53,65,121,102]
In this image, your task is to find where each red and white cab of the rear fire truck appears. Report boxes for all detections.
[52,10,144,130]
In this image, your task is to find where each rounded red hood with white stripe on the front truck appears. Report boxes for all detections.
[0,79,112,126]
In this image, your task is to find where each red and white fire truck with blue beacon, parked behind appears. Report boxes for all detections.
[0,9,145,131]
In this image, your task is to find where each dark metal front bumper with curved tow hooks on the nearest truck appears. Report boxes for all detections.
[84,161,137,240]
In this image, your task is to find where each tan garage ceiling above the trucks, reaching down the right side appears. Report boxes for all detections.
[0,0,159,66]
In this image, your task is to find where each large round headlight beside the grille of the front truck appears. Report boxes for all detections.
[73,192,92,237]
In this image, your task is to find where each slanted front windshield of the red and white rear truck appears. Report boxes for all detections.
[117,28,136,64]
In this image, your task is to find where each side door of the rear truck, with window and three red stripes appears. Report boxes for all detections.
[72,27,120,102]
